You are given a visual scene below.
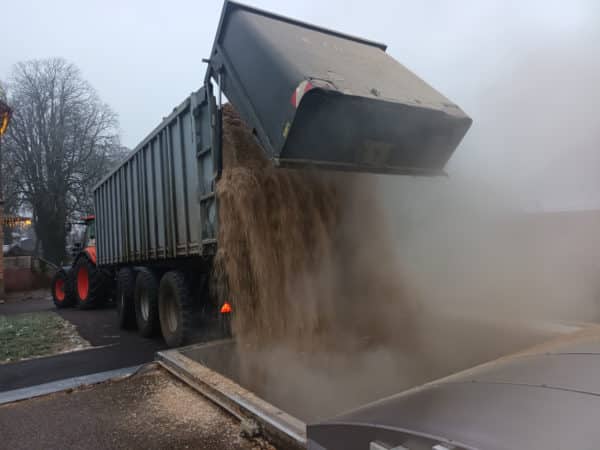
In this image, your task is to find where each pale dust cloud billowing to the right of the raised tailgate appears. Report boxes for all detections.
[379,16,600,321]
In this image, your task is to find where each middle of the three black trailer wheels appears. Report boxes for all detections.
[134,269,160,337]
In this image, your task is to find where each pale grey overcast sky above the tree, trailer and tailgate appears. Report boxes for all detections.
[0,0,600,209]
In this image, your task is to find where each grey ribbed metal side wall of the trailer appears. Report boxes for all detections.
[94,87,218,266]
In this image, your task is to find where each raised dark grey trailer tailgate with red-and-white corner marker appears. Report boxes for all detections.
[209,2,471,175]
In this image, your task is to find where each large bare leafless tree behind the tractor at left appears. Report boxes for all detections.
[5,58,120,263]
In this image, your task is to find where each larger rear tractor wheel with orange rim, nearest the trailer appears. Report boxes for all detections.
[73,256,108,309]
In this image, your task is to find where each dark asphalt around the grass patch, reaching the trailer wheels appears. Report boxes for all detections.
[0,297,165,392]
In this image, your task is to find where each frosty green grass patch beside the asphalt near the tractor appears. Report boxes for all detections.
[0,312,89,364]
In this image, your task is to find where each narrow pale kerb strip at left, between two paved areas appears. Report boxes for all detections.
[0,365,143,405]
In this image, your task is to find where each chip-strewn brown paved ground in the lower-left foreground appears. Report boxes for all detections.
[0,369,272,450]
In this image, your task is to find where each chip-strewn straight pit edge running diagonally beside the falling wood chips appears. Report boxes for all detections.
[156,349,307,449]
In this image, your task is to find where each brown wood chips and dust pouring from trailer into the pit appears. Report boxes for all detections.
[215,106,564,420]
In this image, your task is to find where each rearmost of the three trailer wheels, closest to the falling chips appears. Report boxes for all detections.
[158,270,193,347]
